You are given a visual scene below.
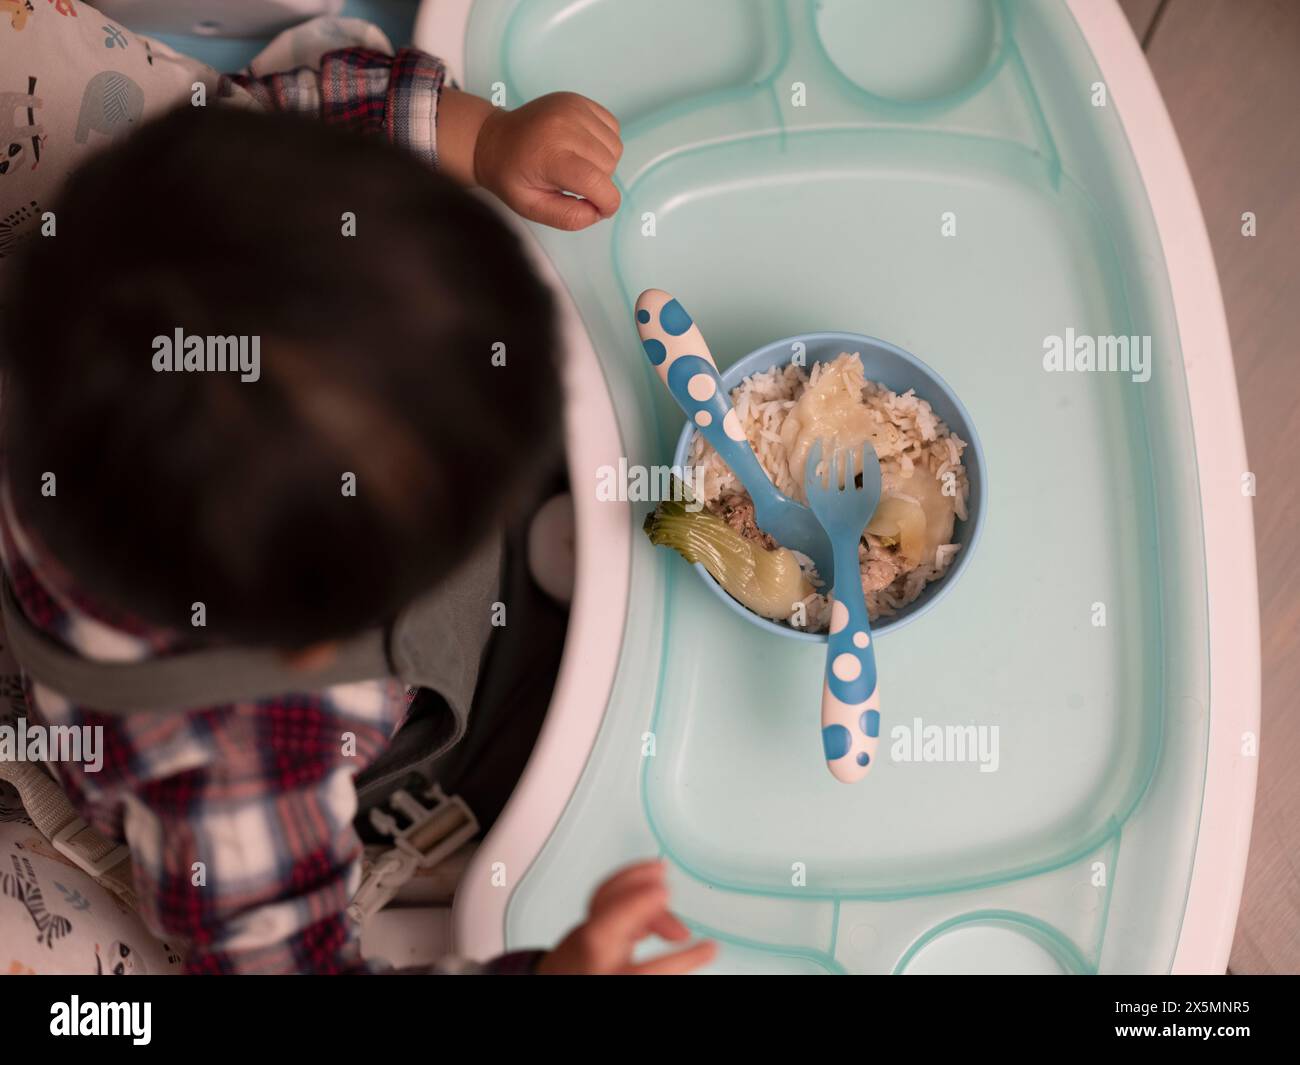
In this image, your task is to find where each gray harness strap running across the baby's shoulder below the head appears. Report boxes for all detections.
[0,531,502,771]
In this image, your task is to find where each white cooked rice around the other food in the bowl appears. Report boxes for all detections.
[690,352,970,632]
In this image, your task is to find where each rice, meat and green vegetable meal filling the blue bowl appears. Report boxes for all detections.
[646,352,970,632]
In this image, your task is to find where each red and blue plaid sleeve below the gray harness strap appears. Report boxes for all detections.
[48,681,406,974]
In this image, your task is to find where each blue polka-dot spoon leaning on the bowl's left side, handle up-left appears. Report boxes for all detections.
[636,289,837,582]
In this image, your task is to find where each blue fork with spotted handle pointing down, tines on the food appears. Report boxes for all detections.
[803,441,880,784]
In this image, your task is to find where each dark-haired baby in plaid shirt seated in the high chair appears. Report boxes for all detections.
[0,5,714,973]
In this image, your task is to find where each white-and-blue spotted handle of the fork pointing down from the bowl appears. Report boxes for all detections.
[822,536,880,784]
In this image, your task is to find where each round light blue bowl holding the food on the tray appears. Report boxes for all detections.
[672,333,987,644]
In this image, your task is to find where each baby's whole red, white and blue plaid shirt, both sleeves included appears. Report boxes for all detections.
[0,48,536,974]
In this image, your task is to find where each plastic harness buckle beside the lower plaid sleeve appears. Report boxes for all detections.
[347,784,478,923]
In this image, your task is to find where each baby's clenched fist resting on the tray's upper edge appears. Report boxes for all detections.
[473,92,623,229]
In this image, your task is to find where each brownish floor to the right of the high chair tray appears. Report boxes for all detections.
[1121,0,1300,973]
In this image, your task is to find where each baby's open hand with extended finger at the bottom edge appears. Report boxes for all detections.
[537,861,718,975]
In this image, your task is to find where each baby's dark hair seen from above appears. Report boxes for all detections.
[0,107,562,649]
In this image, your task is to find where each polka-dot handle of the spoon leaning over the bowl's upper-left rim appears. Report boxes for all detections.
[636,289,776,496]
